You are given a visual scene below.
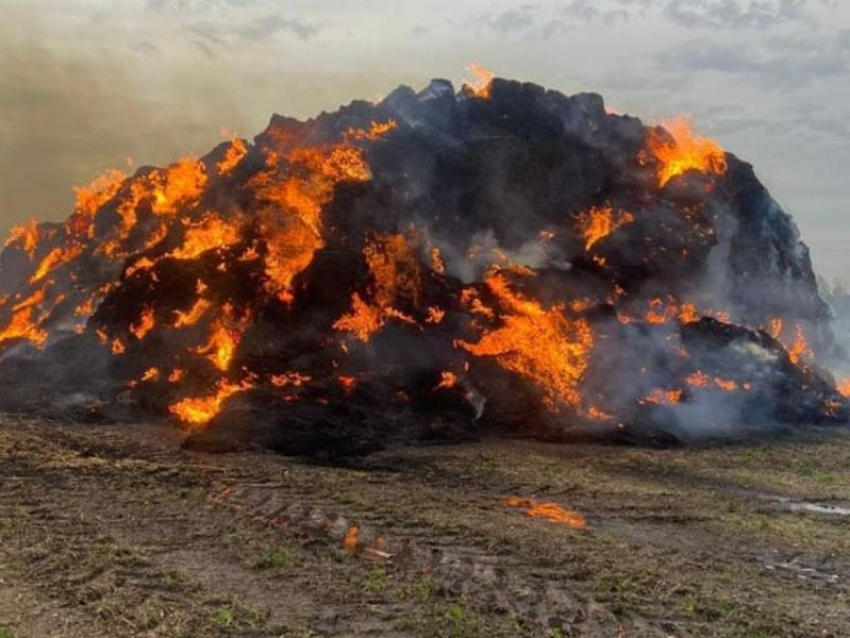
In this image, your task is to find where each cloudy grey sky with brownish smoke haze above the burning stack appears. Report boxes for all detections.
[0,0,850,278]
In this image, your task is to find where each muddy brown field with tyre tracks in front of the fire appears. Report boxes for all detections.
[0,417,850,638]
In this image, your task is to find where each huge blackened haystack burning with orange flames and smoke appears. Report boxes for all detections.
[0,74,850,455]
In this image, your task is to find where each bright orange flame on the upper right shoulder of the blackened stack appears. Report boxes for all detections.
[647,118,727,187]
